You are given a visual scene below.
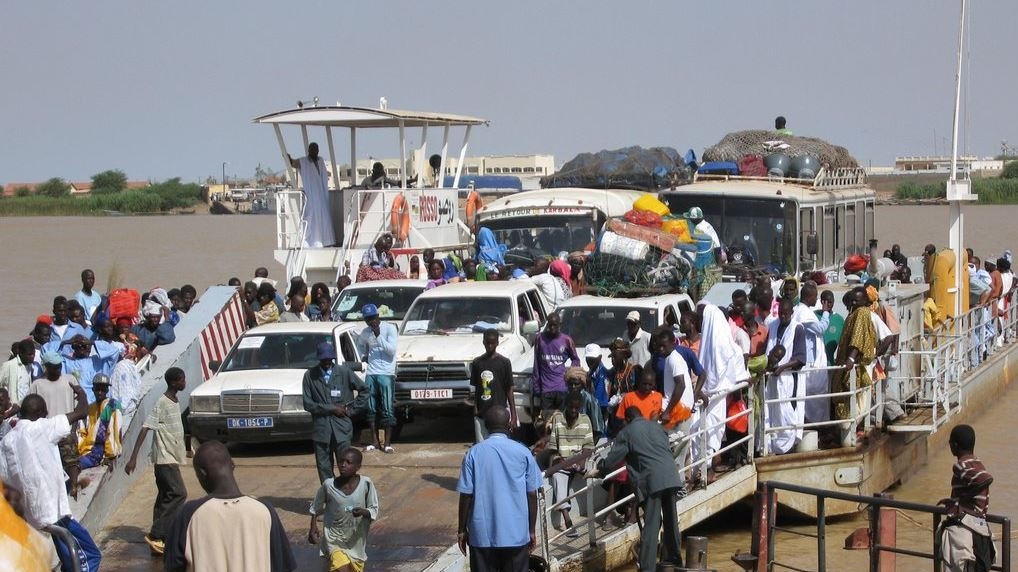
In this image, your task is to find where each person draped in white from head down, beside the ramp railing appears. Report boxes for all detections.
[692,304,749,459]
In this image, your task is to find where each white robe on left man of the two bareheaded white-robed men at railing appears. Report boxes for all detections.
[766,319,805,455]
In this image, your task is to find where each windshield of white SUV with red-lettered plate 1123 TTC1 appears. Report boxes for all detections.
[400,298,513,336]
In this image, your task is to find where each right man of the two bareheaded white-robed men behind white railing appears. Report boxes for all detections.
[793,282,833,423]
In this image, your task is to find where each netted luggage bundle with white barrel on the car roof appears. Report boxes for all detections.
[584,219,721,298]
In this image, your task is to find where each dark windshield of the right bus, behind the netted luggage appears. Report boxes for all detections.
[664,191,795,273]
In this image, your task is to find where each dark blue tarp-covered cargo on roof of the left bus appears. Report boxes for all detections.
[541,146,692,190]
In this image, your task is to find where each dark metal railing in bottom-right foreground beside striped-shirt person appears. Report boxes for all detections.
[747,481,1011,572]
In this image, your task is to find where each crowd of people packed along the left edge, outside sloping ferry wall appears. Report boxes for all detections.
[0,270,197,570]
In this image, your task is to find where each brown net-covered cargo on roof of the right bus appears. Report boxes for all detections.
[703,129,859,169]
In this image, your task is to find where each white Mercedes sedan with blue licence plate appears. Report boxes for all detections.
[187,322,364,443]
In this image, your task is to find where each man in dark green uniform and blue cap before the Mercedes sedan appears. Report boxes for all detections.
[303,342,366,482]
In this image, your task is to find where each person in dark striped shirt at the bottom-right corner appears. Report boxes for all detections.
[938,424,997,572]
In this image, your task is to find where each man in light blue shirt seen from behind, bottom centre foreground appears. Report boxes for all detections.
[456,407,543,572]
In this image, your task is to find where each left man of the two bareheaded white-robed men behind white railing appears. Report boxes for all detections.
[766,298,806,455]
